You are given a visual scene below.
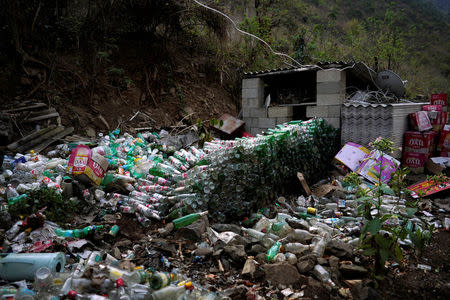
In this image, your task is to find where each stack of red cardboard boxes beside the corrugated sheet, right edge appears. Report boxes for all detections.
[402,94,450,173]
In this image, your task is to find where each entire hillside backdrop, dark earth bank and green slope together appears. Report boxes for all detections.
[0,0,450,136]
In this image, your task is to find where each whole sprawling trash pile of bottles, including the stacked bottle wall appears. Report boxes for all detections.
[0,114,450,299]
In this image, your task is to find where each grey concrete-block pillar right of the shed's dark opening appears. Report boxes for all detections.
[306,69,346,128]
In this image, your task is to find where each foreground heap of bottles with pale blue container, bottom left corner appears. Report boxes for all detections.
[0,251,227,300]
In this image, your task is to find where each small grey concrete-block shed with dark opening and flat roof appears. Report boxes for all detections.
[242,62,376,135]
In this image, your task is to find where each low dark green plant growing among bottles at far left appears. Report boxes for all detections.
[8,187,76,223]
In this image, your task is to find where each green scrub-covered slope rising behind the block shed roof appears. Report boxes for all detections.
[222,0,450,97]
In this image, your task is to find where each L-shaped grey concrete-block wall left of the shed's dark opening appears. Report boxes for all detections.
[242,78,293,135]
